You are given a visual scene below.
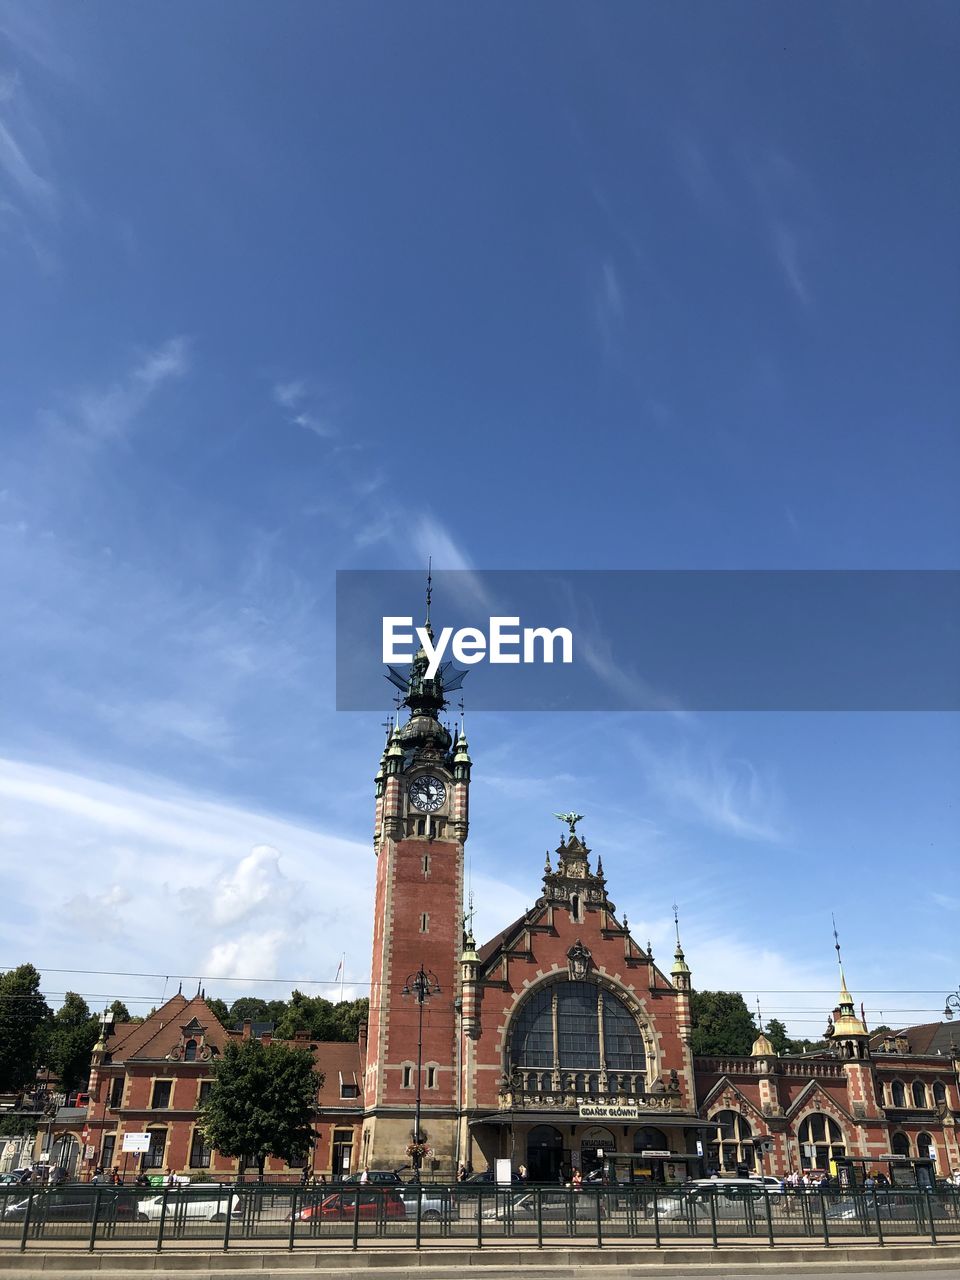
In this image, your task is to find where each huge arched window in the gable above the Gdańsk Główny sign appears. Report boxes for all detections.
[509,982,646,1093]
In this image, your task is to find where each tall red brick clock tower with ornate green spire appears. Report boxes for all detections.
[361,579,471,1176]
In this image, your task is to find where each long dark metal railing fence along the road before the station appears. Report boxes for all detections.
[0,1181,960,1252]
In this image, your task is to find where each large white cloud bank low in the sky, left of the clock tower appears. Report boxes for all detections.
[0,759,375,1001]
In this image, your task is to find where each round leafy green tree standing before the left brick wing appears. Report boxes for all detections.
[200,1039,324,1179]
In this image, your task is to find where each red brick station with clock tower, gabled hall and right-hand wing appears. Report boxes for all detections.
[361,620,960,1179]
